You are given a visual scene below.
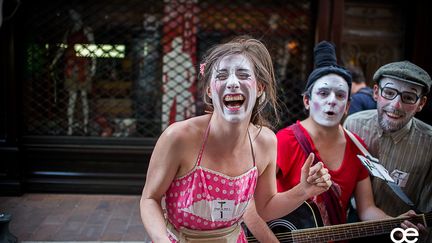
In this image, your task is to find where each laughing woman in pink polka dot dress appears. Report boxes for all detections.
[140,37,331,242]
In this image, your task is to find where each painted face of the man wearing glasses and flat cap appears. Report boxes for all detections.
[375,78,422,132]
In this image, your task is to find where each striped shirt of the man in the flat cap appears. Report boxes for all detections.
[344,109,432,216]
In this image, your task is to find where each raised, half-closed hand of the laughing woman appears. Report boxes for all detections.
[300,153,332,197]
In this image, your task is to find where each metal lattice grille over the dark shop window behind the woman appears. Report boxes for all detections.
[21,0,313,137]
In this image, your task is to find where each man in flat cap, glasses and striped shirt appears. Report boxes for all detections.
[344,61,432,242]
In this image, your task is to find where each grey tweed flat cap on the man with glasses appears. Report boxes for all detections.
[373,61,432,94]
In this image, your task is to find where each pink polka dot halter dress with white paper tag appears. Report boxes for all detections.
[165,125,258,242]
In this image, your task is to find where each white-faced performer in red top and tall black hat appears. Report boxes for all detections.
[246,41,416,241]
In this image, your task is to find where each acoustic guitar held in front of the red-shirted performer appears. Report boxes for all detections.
[245,202,432,243]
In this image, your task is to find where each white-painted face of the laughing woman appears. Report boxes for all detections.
[210,55,257,123]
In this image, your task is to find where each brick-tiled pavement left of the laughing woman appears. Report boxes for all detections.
[0,194,149,242]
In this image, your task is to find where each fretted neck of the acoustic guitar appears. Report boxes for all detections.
[286,214,432,242]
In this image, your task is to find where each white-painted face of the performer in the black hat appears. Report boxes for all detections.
[309,74,348,127]
